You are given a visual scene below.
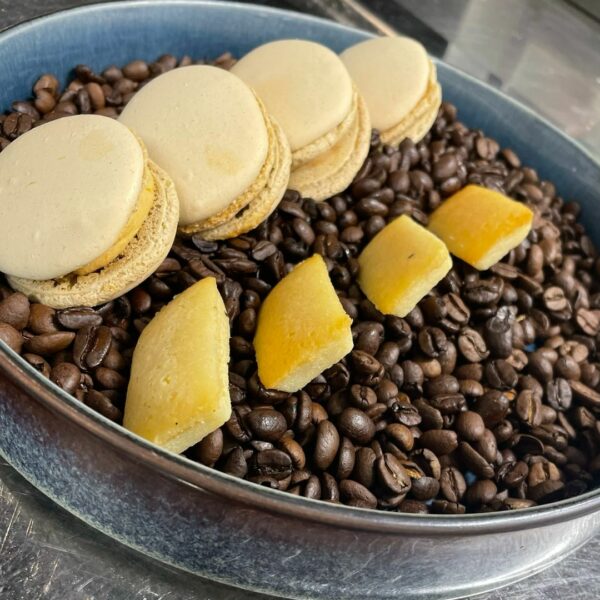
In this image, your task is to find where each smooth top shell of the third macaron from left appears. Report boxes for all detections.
[231,40,353,152]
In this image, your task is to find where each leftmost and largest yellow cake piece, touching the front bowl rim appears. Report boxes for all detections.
[123,277,231,453]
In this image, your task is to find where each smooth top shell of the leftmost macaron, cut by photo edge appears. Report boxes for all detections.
[0,115,144,279]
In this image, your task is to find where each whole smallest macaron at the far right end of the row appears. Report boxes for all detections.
[340,37,442,145]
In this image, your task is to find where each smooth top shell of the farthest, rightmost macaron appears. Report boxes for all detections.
[340,37,430,131]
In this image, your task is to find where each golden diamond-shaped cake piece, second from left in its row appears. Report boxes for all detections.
[254,254,352,392]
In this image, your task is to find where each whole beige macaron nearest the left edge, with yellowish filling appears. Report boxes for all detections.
[0,115,179,308]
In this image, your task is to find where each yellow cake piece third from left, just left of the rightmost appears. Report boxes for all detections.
[358,215,452,317]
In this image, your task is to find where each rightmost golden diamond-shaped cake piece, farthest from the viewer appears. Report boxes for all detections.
[429,185,533,271]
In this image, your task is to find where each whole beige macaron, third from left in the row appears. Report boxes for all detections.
[231,40,371,200]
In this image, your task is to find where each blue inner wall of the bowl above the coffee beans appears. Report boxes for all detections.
[0,1,600,528]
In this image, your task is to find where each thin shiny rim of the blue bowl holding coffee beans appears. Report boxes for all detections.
[0,0,600,537]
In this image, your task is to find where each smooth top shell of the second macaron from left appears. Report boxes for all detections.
[120,65,269,225]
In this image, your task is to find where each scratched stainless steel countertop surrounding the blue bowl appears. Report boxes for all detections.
[0,0,600,600]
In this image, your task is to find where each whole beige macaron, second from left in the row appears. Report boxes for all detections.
[119,65,291,240]
